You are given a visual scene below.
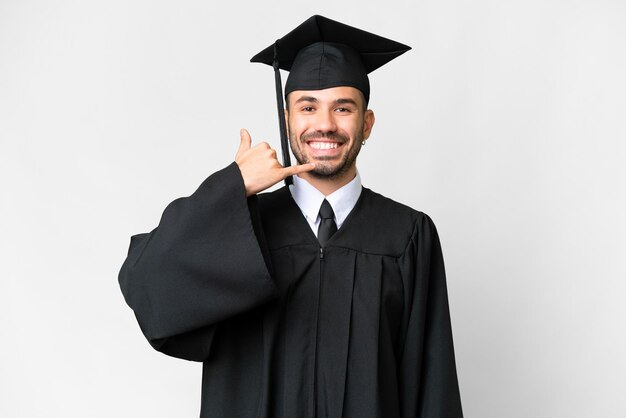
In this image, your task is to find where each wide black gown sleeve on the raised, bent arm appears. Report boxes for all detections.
[119,163,276,361]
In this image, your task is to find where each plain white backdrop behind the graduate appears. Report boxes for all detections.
[0,0,626,418]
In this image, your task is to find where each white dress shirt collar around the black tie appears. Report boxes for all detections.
[289,172,362,236]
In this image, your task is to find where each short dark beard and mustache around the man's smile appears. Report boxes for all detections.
[290,132,363,180]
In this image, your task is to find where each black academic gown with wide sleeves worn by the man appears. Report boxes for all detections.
[119,163,462,418]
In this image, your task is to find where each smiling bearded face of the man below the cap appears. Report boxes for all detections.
[287,87,374,179]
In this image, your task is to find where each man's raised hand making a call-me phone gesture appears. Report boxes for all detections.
[235,129,315,196]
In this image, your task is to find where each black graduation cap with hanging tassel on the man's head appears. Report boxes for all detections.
[250,15,411,184]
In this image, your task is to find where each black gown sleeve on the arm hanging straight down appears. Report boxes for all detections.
[400,214,463,418]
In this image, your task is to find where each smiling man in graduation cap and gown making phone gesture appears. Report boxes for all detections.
[120,16,462,418]
